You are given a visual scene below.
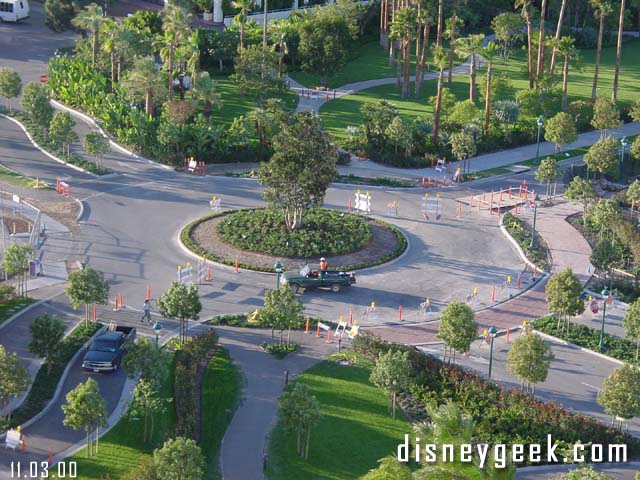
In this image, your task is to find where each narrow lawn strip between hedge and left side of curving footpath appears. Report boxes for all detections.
[200,347,242,480]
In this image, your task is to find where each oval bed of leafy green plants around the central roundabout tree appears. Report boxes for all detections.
[216,208,371,258]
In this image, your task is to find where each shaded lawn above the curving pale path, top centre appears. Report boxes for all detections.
[289,41,464,88]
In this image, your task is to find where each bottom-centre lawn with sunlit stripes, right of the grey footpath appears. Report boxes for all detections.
[266,352,411,480]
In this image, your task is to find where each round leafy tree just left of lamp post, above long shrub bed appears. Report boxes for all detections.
[436,302,478,363]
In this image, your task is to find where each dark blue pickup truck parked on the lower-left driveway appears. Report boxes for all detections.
[82,326,136,373]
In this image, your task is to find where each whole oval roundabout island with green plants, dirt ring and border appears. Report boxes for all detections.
[180,208,408,273]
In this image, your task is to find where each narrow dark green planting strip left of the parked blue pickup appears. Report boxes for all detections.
[11,322,102,427]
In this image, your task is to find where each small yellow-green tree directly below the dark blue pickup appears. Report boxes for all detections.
[62,378,107,457]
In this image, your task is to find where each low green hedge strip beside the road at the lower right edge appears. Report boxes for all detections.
[533,317,638,363]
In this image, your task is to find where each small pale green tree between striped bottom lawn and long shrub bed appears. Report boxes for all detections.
[369,350,411,418]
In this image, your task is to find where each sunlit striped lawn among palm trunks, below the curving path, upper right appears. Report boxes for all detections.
[320,40,640,137]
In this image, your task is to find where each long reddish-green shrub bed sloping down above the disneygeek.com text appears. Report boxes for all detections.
[353,333,640,464]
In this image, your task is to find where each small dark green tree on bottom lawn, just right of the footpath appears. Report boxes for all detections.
[278,382,321,460]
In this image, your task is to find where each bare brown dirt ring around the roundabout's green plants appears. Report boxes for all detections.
[191,215,399,270]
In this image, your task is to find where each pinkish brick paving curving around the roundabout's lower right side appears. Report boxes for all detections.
[372,202,592,345]
